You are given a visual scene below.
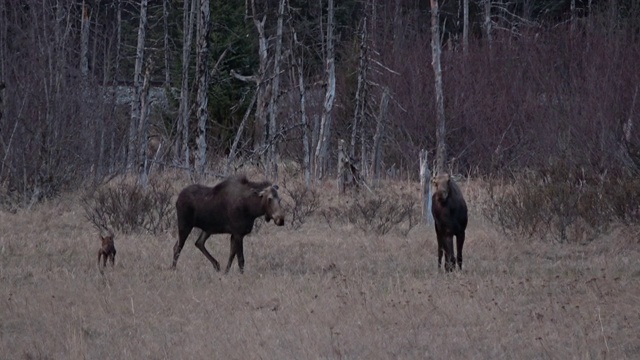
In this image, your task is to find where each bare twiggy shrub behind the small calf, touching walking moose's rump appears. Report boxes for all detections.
[82,181,175,234]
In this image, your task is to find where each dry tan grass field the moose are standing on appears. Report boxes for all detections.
[0,176,640,359]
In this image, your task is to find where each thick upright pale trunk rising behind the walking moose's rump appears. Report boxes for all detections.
[196,0,210,174]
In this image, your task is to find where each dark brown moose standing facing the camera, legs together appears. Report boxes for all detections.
[431,174,468,271]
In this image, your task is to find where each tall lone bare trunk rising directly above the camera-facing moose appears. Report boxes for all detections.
[431,0,444,174]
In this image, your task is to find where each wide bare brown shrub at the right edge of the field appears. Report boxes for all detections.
[483,163,640,242]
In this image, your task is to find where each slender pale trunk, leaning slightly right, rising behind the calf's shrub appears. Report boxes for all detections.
[127,0,148,171]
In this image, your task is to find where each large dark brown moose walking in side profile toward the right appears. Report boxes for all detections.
[171,175,284,273]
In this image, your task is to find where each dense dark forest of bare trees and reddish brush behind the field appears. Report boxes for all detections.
[0,0,640,201]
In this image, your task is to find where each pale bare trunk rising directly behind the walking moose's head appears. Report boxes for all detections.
[267,0,285,181]
